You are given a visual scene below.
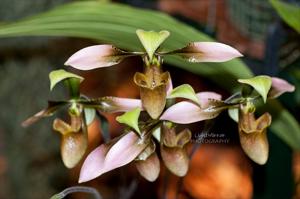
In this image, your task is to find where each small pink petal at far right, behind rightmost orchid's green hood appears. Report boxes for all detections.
[268,77,295,98]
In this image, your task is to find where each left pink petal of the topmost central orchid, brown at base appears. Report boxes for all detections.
[65,45,125,70]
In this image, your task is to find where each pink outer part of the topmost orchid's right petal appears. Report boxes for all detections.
[189,42,243,62]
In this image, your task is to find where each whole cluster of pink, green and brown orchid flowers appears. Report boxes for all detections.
[23,30,295,183]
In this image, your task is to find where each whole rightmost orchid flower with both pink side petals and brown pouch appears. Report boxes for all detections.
[160,76,295,164]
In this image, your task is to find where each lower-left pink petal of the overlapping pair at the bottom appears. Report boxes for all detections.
[79,144,109,183]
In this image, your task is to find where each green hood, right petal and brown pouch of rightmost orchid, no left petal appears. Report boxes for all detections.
[229,75,295,164]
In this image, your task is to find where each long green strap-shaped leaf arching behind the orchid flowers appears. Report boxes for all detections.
[0,1,300,149]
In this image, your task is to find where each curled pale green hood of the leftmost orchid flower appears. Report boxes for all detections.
[49,69,84,90]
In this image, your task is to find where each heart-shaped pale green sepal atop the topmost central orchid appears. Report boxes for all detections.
[136,29,170,61]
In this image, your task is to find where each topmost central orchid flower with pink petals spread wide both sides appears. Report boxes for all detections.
[65,30,242,119]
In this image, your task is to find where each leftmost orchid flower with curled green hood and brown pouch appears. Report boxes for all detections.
[22,70,141,168]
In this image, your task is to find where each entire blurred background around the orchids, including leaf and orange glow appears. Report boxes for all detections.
[0,0,300,199]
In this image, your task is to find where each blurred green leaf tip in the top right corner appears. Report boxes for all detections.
[269,0,300,33]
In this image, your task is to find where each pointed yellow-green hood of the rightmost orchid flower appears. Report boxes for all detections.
[238,75,272,103]
